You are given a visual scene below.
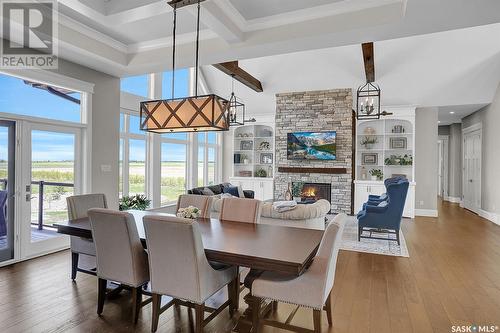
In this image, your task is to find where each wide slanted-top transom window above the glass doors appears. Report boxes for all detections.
[0,74,82,123]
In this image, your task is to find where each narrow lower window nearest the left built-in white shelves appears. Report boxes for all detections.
[197,132,219,186]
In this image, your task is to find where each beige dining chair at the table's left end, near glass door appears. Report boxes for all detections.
[66,193,108,280]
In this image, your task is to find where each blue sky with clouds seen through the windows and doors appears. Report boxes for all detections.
[0,69,199,161]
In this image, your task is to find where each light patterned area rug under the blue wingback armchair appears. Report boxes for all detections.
[340,216,410,257]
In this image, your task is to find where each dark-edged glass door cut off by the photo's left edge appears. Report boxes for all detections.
[0,120,16,264]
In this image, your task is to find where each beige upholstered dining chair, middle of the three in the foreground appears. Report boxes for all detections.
[143,216,238,333]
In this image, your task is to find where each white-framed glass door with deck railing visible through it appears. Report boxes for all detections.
[21,122,82,258]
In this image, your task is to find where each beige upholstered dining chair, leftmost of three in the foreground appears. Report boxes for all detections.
[88,208,151,323]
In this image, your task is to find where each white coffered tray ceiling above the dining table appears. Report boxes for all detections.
[1,0,500,77]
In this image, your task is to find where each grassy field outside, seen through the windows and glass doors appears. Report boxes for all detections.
[0,161,215,224]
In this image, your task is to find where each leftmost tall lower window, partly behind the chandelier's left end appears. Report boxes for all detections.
[119,112,147,196]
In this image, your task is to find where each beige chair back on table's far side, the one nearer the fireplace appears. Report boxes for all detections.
[220,198,262,223]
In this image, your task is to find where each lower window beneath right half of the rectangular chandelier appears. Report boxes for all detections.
[160,133,188,205]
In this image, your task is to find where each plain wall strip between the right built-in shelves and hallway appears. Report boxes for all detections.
[415,108,439,216]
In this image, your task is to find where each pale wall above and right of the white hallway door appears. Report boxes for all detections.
[462,84,500,216]
